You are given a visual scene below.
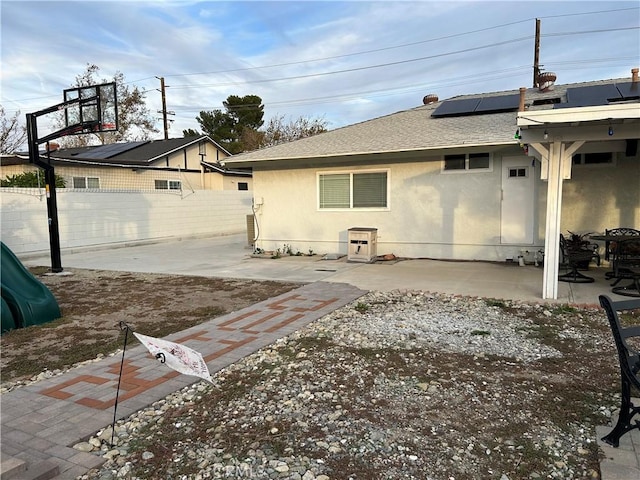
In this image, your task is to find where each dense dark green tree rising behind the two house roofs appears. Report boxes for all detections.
[188,95,264,154]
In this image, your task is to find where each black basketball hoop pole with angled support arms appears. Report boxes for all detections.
[27,97,97,273]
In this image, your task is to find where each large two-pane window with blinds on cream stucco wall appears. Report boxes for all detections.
[318,171,389,209]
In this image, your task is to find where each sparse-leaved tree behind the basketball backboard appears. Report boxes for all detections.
[58,64,159,148]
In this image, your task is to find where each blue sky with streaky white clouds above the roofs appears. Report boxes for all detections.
[0,0,640,138]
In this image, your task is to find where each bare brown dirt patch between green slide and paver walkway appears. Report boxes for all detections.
[0,267,300,383]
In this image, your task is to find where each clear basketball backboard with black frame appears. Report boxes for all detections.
[64,82,118,134]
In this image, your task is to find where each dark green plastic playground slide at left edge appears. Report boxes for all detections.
[0,242,61,332]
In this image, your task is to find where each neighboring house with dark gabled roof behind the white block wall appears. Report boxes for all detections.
[0,136,252,191]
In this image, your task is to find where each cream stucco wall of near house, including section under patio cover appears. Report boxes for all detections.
[253,151,640,261]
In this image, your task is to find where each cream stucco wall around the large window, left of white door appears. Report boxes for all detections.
[254,155,540,260]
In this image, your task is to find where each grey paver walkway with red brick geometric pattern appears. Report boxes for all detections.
[0,282,366,479]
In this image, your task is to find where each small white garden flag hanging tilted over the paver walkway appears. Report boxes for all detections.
[133,332,213,383]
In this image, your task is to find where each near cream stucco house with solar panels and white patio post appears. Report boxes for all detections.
[225,69,640,298]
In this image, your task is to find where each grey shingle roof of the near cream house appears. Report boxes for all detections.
[225,74,637,166]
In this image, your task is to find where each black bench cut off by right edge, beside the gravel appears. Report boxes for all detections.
[598,295,640,447]
